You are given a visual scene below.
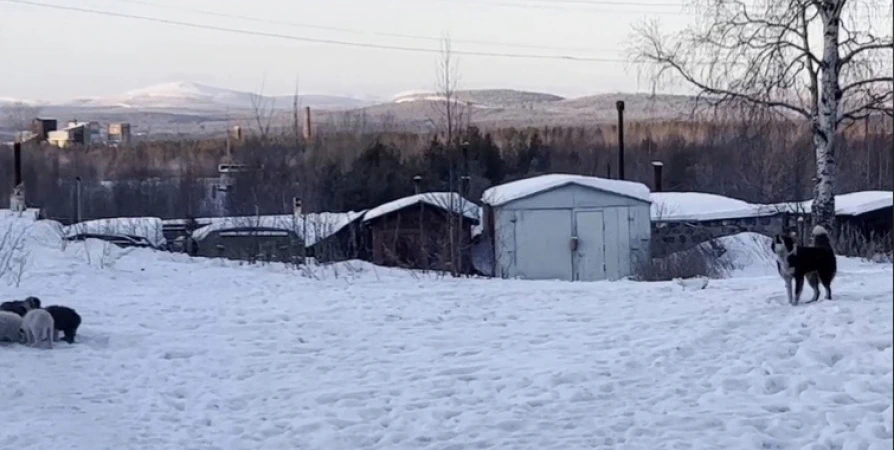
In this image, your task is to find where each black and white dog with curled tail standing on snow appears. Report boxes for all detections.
[770,225,838,305]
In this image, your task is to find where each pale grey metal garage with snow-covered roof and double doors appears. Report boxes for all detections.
[482,174,651,281]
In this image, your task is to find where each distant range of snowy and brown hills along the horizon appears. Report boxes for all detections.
[0,82,712,135]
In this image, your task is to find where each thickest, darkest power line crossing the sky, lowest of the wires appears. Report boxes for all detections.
[0,0,628,63]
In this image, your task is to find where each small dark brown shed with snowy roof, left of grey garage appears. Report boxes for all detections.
[363,192,479,273]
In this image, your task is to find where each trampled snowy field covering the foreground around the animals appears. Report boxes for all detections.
[0,216,894,450]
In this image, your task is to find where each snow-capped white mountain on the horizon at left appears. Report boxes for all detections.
[60,81,368,111]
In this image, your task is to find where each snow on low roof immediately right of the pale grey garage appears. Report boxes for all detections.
[650,192,775,221]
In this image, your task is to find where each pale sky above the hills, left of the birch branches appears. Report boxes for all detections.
[0,0,689,100]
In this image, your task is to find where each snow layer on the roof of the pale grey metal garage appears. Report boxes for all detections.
[481,174,649,206]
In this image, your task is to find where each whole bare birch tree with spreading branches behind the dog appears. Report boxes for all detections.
[634,0,894,227]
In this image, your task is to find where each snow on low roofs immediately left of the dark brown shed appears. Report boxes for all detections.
[192,211,364,246]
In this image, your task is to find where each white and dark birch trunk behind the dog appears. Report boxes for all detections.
[812,5,841,231]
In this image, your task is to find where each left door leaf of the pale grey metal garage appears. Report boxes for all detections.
[515,209,572,280]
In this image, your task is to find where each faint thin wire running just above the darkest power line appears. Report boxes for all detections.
[116,0,624,52]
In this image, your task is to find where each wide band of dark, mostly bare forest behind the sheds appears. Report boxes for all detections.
[0,114,894,222]
